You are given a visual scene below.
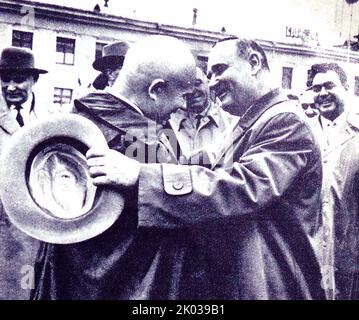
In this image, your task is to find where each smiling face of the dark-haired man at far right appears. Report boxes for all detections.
[312,70,346,120]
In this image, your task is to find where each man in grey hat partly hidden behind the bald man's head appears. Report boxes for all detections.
[92,41,129,90]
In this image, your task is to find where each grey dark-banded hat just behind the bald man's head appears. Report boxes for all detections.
[92,41,129,72]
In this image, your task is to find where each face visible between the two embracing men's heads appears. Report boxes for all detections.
[187,68,209,113]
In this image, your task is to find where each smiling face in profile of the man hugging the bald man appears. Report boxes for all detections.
[208,40,254,115]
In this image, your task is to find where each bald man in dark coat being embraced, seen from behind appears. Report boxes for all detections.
[32,36,201,300]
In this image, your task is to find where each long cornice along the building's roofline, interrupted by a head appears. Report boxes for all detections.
[0,0,359,63]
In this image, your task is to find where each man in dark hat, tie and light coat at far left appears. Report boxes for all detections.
[0,47,47,299]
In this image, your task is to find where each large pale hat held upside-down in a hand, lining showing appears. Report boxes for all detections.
[0,114,124,244]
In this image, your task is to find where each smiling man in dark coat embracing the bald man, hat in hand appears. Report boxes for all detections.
[88,39,325,299]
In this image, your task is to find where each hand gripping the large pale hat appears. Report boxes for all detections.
[86,148,141,188]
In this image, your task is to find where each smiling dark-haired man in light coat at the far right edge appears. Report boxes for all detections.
[308,63,359,300]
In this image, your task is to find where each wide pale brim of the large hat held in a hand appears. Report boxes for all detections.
[0,114,124,244]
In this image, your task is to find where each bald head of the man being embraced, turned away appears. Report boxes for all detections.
[115,36,196,121]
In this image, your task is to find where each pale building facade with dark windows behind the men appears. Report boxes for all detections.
[0,0,359,108]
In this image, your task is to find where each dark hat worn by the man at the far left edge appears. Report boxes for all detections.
[0,47,47,74]
